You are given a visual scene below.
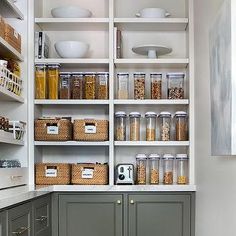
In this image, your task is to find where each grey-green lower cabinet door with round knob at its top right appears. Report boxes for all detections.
[59,194,122,236]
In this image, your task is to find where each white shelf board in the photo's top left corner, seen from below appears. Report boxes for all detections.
[0,0,24,20]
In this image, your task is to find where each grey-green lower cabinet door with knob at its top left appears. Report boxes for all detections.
[128,195,191,236]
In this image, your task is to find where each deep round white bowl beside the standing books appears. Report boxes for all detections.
[54,41,89,58]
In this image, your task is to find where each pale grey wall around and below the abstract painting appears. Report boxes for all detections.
[194,0,236,236]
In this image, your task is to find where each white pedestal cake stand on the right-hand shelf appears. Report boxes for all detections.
[132,45,172,58]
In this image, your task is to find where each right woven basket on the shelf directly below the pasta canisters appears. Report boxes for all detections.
[74,119,108,141]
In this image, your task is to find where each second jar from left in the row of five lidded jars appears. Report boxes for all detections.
[129,112,141,141]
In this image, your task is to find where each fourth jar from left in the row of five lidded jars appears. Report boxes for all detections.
[158,112,171,141]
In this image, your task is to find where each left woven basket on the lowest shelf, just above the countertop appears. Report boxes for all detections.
[35,163,71,185]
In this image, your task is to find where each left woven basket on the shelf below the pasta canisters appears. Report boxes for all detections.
[35,119,72,141]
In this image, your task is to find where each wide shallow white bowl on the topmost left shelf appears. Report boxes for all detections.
[51,6,92,18]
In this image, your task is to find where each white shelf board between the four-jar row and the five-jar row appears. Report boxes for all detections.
[114,99,189,105]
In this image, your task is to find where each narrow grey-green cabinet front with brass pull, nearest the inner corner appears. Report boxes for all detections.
[33,196,51,236]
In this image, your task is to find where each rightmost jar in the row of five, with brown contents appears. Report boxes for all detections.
[174,111,188,141]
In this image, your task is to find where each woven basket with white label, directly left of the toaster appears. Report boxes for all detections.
[71,163,108,185]
